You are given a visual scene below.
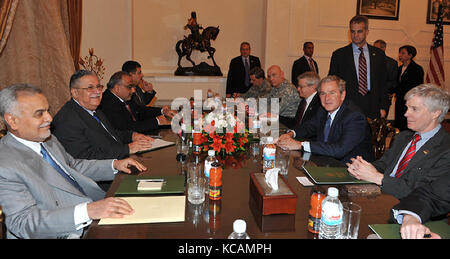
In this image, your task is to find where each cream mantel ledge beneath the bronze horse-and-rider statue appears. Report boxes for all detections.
[144,74,227,106]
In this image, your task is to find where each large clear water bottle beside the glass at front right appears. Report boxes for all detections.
[319,187,343,239]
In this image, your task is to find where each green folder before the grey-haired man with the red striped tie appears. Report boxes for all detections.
[303,165,370,184]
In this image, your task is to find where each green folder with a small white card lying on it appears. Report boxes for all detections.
[114,175,185,196]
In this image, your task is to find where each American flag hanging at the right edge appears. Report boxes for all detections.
[425,4,445,88]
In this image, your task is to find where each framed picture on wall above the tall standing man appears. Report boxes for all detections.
[356,0,400,21]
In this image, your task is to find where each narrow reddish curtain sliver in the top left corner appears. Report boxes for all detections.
[0,0,19,54]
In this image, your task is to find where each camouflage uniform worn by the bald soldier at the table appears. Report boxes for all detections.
[262,79,300,118]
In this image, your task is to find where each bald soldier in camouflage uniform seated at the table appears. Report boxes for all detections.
[264,65,300,123]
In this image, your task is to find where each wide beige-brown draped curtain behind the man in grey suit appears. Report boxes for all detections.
[0,0,75,114]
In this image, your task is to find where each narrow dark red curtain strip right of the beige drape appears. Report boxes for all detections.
[67,0,83,70]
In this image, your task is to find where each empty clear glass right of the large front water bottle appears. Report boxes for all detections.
[341,202,361,239]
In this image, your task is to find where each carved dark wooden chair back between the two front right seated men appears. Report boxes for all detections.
[367,118,400,159]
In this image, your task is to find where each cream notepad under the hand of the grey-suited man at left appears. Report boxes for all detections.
[98,196,186,225]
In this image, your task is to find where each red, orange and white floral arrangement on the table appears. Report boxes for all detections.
[200,112,251,155]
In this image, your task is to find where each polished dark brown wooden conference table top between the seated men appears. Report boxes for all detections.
[84,129,398,239]
